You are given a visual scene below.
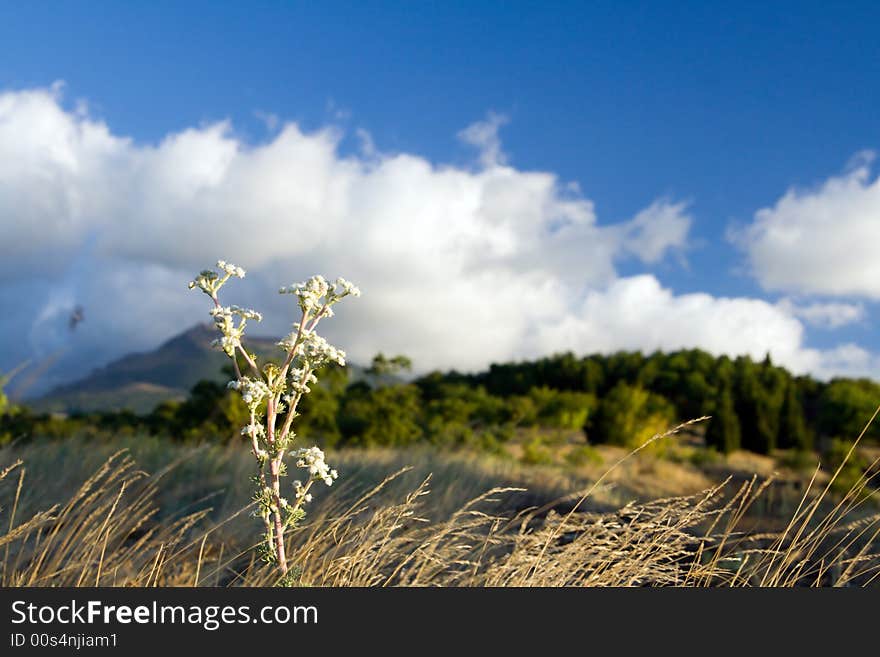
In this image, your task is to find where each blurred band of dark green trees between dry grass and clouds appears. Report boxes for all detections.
[0,349,880,454]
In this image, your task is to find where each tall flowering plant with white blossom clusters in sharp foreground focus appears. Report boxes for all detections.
[189,260,360,585]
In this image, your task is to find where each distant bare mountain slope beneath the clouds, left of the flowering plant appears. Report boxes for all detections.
[28,324,277,413]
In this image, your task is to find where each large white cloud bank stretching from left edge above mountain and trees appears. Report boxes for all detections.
[0,88,880,392]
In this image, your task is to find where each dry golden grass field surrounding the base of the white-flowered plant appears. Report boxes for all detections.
[0,416,880,586]
